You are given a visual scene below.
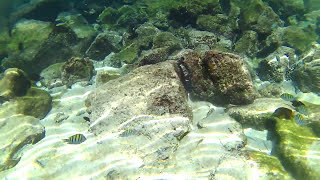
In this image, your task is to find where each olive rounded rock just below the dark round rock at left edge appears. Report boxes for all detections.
[15,87,52,119]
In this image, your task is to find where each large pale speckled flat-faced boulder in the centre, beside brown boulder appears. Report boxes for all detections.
[86,61,191,134]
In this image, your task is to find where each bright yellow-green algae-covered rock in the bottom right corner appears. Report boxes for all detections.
[275,118,320,179]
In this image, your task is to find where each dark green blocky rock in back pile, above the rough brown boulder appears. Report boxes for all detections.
[196,14,238,38]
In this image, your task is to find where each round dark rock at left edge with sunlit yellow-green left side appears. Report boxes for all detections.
[0,68,31,100]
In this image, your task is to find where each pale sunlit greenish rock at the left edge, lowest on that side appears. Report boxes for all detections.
[0,114,45,171]
